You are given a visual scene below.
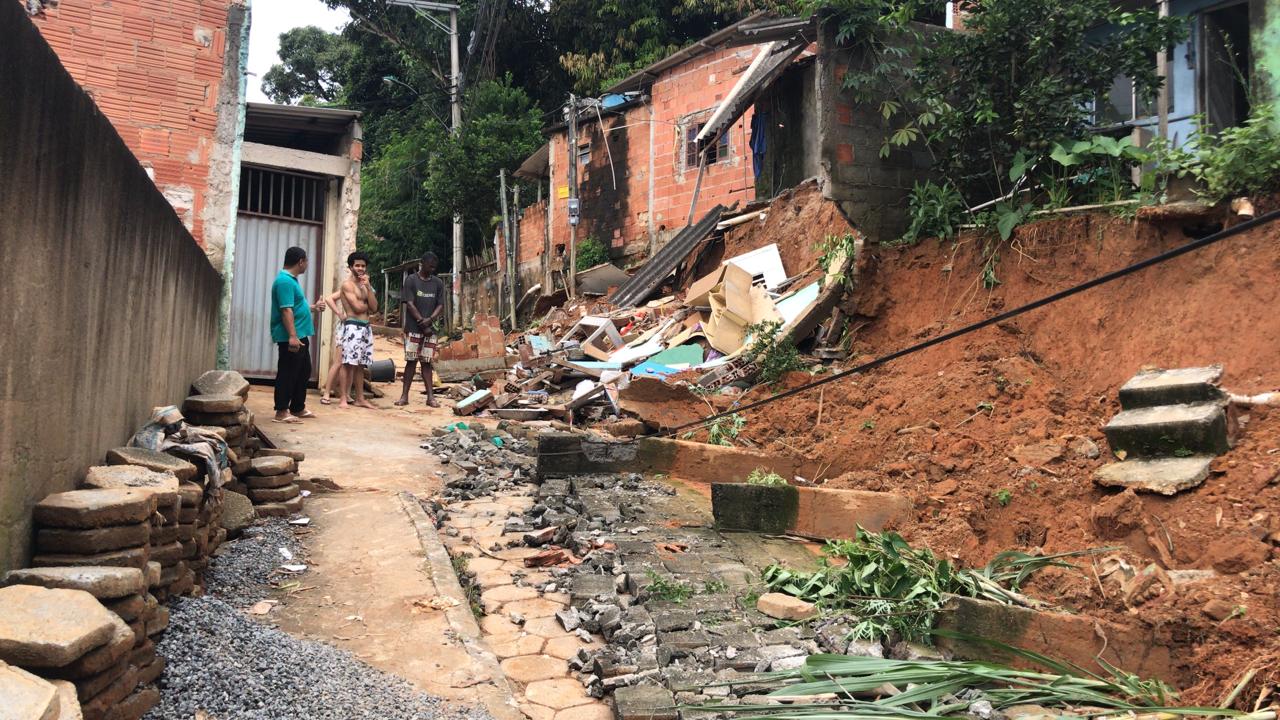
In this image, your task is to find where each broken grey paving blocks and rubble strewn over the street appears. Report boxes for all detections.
[424,425,920,720]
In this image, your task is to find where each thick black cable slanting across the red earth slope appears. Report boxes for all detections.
[659,204,1280,437]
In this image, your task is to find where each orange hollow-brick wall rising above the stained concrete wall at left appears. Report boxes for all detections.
[23,0,240,246]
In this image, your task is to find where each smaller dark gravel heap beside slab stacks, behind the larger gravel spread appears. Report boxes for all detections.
[206,518,306,607]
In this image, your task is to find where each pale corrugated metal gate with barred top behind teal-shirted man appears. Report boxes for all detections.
[230,168,325,379]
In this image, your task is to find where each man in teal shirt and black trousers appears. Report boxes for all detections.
[271,247,316,423]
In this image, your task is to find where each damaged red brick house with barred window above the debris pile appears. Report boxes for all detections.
[516,13,928,292]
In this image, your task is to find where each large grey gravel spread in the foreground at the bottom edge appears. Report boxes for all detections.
[146,596,490,720]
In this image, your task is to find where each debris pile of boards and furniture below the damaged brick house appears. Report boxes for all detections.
[437,193,861,436]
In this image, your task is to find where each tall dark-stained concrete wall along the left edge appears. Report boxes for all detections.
[0,3,221,571]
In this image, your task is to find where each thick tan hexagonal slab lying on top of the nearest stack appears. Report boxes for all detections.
[0,585,119,667]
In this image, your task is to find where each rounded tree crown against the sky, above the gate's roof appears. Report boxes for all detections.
[262,26,355,104]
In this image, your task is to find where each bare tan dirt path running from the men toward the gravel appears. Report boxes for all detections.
[248,371,502,706]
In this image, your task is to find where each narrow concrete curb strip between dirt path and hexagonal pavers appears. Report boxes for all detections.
[399,492,527,720]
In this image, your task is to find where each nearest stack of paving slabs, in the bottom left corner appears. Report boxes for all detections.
[0,579,164,720]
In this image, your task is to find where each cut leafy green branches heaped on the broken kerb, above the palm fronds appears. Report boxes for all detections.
[764,528,1091,641]
